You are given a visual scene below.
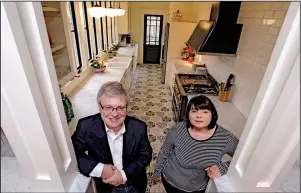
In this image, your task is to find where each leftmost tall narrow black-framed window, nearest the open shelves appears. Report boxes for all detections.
[69,1,82,73]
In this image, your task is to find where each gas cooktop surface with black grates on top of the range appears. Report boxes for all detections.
[176,73,218,95]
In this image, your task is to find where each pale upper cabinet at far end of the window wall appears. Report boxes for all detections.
[117,2,130,34]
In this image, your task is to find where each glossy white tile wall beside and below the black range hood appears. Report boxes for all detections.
[200,2,290,118]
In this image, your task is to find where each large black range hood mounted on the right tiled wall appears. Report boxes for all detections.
[187,1,243,56]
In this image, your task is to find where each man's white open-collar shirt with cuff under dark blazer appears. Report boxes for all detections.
[89,124,127,182]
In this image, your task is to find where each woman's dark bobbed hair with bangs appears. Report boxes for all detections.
[186,95,218,129]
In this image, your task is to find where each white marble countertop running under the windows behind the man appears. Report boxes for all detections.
[65,47,134,192]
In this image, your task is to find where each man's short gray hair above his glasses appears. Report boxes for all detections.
[97,81,128,105]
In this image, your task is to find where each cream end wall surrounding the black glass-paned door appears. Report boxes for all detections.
[130,2,169,63]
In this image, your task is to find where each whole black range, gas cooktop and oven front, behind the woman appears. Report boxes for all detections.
[172,73,218,122]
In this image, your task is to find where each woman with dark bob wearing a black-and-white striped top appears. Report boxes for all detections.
[154,95,238,193]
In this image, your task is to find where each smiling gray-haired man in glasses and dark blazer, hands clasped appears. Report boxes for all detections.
[72,82,152,193]
